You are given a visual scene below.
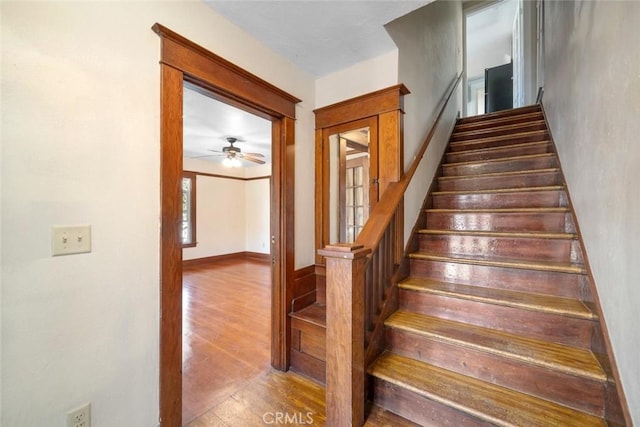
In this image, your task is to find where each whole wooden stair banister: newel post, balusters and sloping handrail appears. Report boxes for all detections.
[318,74,462,427]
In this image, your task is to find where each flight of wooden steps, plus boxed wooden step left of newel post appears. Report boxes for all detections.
[292,106,625,426]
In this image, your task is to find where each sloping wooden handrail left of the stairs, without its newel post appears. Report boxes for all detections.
[356,73,462,248]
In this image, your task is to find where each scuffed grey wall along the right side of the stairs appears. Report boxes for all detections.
[543,1,640,424]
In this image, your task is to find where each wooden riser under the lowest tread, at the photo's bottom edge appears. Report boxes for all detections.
[373,378,494,427]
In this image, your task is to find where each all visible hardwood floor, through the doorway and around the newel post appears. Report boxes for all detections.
[182,260,416,427]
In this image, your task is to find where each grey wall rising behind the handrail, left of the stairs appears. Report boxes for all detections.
[385,1,462,241]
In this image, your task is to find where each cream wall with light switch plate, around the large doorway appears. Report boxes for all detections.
[0,2,315,427]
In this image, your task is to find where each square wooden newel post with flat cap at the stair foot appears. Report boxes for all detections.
[318,244,371,427]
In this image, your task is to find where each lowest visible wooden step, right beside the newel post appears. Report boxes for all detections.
[369,352,607,427]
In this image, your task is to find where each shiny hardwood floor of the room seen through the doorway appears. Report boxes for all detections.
[182,260,271,425]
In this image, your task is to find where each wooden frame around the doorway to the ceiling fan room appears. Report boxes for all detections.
[153,24,300,427]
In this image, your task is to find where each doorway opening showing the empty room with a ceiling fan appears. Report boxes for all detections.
[182,83,272,425]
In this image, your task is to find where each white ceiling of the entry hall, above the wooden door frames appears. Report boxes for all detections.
[205,0,433,77]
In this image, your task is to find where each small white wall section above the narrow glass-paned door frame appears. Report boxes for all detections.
[316,49,398,108]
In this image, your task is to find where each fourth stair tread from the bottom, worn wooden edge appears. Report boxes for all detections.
[409,252,586,274]
